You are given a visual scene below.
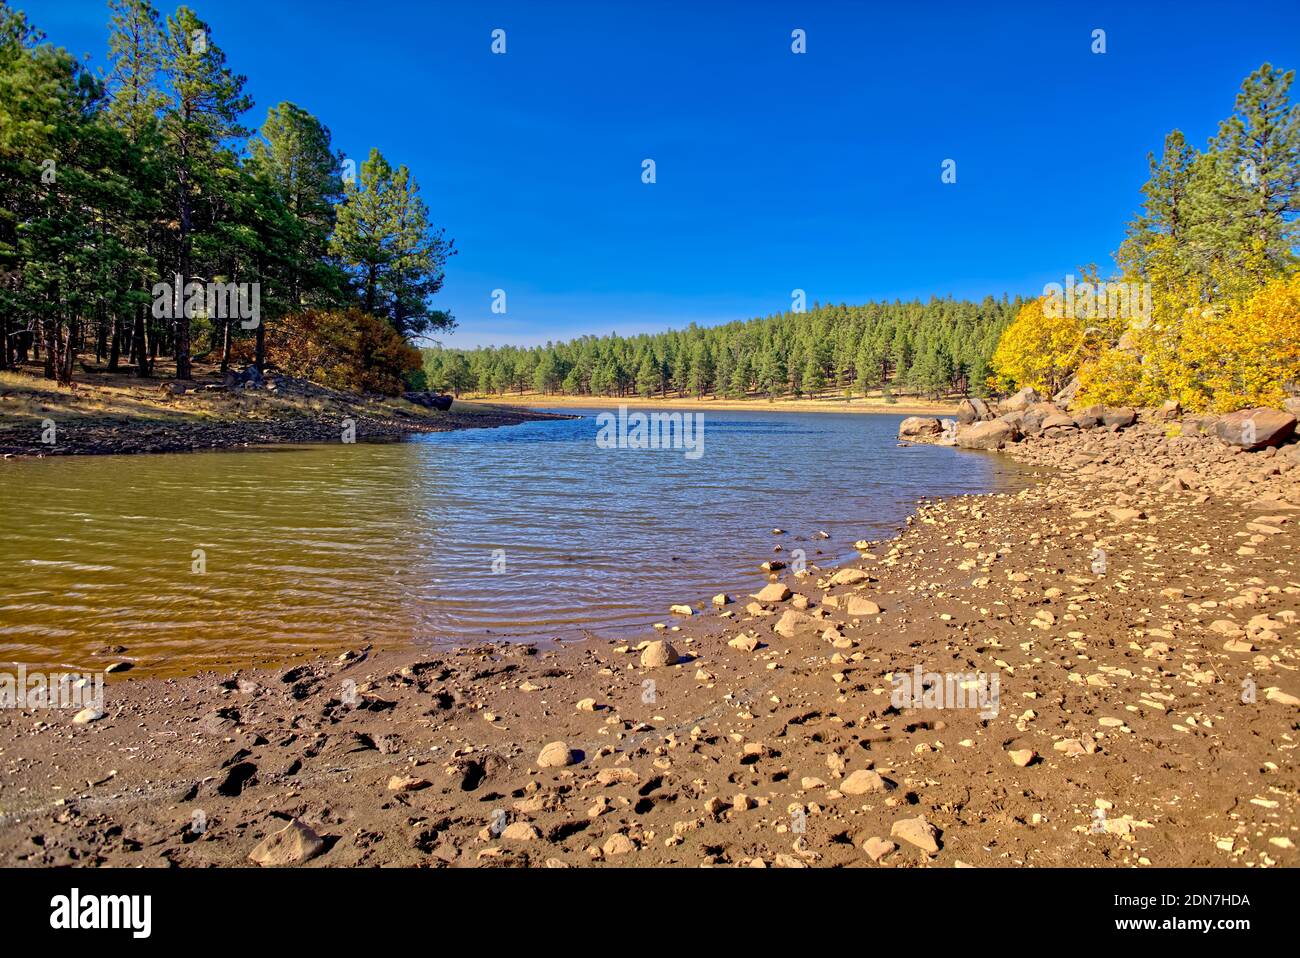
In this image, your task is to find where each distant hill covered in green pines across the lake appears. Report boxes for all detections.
[424,296,1023,398]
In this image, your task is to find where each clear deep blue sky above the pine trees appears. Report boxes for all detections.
[32,0,1300,347]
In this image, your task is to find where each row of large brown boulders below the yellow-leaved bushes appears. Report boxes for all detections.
[898,387,1300,450]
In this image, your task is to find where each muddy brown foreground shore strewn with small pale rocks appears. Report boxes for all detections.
[0,410,1300,867]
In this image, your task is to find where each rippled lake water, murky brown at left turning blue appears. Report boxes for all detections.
[0,409,1024,673]
